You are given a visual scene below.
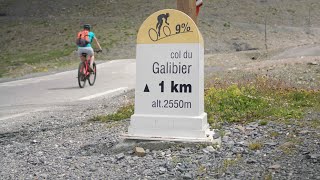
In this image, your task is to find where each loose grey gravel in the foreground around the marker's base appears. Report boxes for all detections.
[0,92,320,179]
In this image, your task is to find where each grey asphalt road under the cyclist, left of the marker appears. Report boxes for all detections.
[0,59,136,121]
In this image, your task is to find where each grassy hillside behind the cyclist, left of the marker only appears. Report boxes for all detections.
[0,0,174,76]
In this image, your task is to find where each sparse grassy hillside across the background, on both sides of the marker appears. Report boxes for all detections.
[0,0,320,77]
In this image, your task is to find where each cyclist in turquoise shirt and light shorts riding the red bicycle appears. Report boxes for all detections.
[78,24,102,70]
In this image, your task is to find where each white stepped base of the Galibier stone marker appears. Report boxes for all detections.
[126,113,212,142]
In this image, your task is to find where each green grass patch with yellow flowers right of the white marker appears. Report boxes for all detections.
[205,78,320,128]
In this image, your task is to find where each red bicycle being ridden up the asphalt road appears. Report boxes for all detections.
[78,51,101,88]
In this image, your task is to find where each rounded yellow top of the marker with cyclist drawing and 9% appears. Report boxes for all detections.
[137,9,203,46]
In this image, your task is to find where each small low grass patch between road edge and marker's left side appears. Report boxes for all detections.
[91,104,134,122]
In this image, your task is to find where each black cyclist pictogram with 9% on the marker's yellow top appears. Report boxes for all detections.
[148,13,192,41]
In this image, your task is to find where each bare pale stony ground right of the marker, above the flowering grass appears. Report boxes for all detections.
[205,48,320,90]
